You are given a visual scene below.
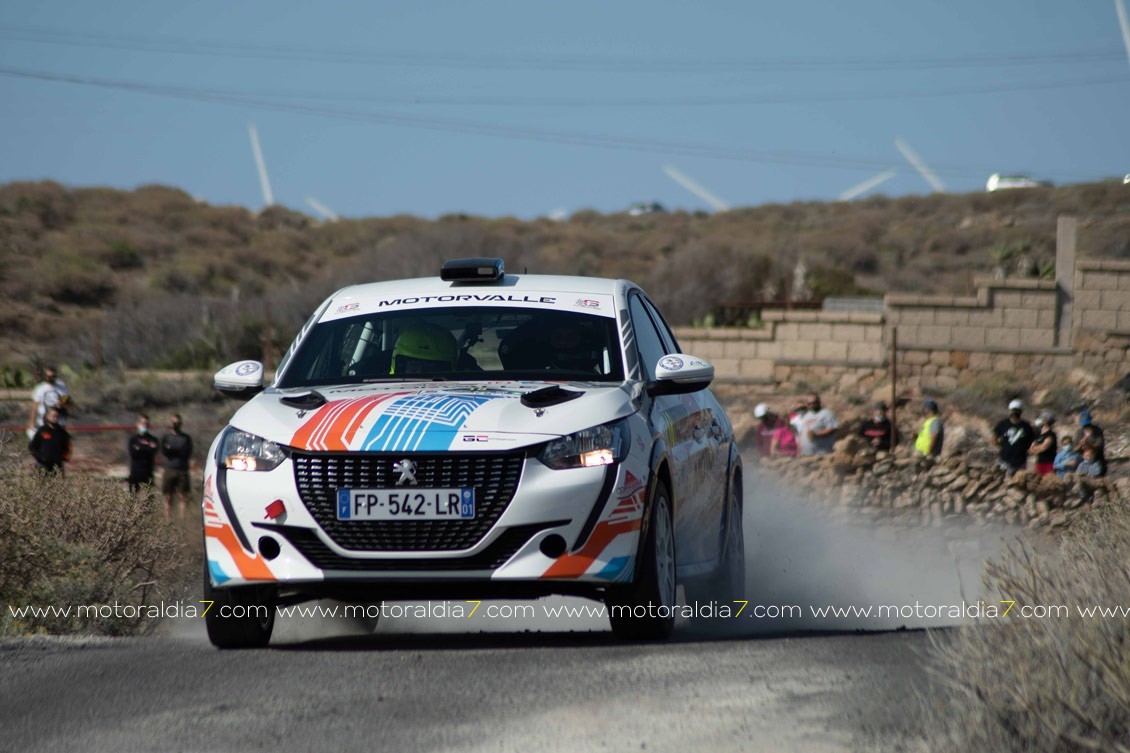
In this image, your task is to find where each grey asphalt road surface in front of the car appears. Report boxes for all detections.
[0,619,928,753]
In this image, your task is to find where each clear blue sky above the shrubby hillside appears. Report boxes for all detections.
[0,0,1130,218]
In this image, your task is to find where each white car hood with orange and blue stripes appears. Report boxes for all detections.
[232,382,635,452]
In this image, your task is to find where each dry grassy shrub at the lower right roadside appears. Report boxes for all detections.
[929,509,1130,752]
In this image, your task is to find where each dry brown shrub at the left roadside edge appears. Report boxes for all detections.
[0,452,185,635]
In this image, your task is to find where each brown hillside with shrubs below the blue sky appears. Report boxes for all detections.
[0,176,1130,375]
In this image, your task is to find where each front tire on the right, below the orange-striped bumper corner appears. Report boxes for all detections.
[605,482,677,641]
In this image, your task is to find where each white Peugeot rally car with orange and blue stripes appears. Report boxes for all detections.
[202,259,745,648]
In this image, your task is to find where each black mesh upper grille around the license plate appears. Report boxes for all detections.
[290,450,525,552]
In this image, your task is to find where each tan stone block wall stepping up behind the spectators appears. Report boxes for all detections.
[677,218,1130,391]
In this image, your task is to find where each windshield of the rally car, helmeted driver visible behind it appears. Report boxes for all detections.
[279,306,624,388]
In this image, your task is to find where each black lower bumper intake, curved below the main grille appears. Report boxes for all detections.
[255,520,567,572]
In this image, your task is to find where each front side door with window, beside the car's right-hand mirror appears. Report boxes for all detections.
[628,293,724,570]
